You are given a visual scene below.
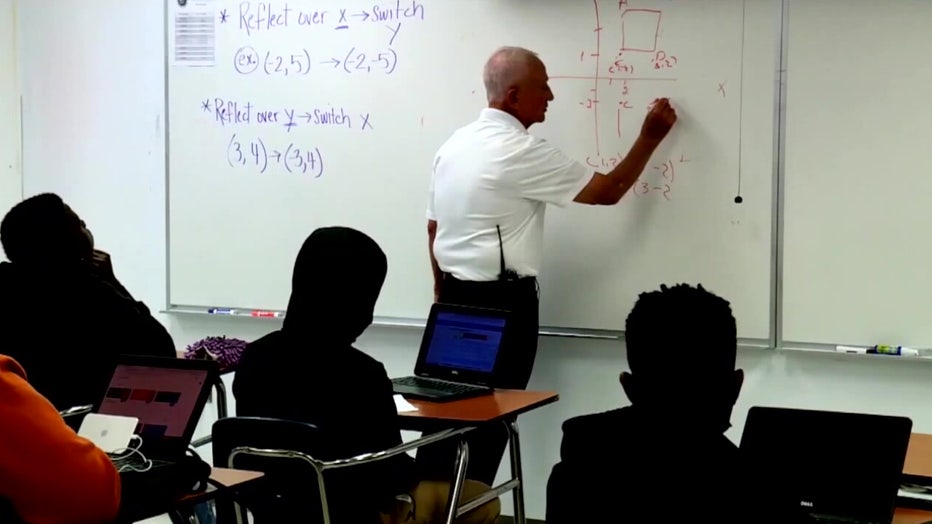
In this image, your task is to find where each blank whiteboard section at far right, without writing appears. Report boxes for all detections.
[782,0,932,347]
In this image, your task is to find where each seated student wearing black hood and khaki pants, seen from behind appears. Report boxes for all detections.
[233,227,500,524]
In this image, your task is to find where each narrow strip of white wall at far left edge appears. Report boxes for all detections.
[0,0,23,221]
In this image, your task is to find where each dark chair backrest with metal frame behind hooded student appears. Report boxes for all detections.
[211,417,332,524]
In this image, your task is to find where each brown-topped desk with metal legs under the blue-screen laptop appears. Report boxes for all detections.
[398,389,560,524]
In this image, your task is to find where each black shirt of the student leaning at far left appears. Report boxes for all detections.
[0,262,176,410]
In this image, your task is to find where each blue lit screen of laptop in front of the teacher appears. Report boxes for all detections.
[426,311,505,373]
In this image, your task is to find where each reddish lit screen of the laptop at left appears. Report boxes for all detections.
[98,364,210,448]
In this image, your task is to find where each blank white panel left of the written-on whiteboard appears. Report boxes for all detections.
[19,0,166,302]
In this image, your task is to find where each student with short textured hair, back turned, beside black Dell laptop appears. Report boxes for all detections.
[547,284,744,524]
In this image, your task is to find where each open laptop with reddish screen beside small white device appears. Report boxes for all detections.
[94,356,220,466]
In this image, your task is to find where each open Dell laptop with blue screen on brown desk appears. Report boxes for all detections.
[392,304,511,402]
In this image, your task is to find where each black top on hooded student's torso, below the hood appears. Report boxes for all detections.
[233,331,417,524]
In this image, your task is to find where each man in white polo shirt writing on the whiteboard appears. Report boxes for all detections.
[427,47,676,484]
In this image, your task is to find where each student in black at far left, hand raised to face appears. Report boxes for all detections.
[0,193,176,410]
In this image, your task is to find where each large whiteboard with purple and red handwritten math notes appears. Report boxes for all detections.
[167,0,780,338]
